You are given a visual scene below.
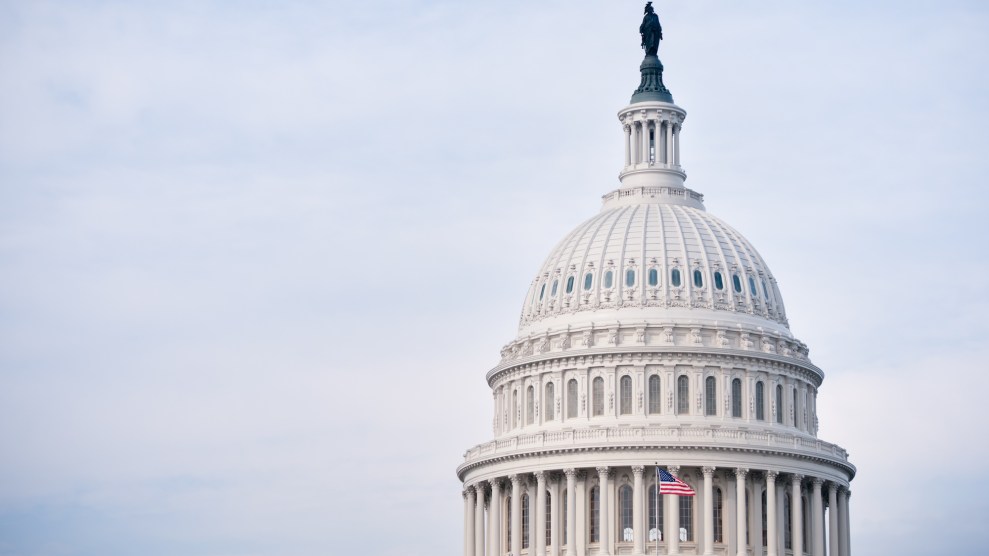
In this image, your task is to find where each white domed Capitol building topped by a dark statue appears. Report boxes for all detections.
[457,7,855,556]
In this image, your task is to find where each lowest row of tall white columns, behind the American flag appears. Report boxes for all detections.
[464,465,851,556]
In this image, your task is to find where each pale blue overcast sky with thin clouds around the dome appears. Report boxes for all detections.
[0,0,989,556]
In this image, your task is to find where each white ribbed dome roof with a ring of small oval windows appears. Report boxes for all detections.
[519,188,790,337]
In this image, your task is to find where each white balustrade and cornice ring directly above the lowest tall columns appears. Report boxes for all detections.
[464,427,848,463]
